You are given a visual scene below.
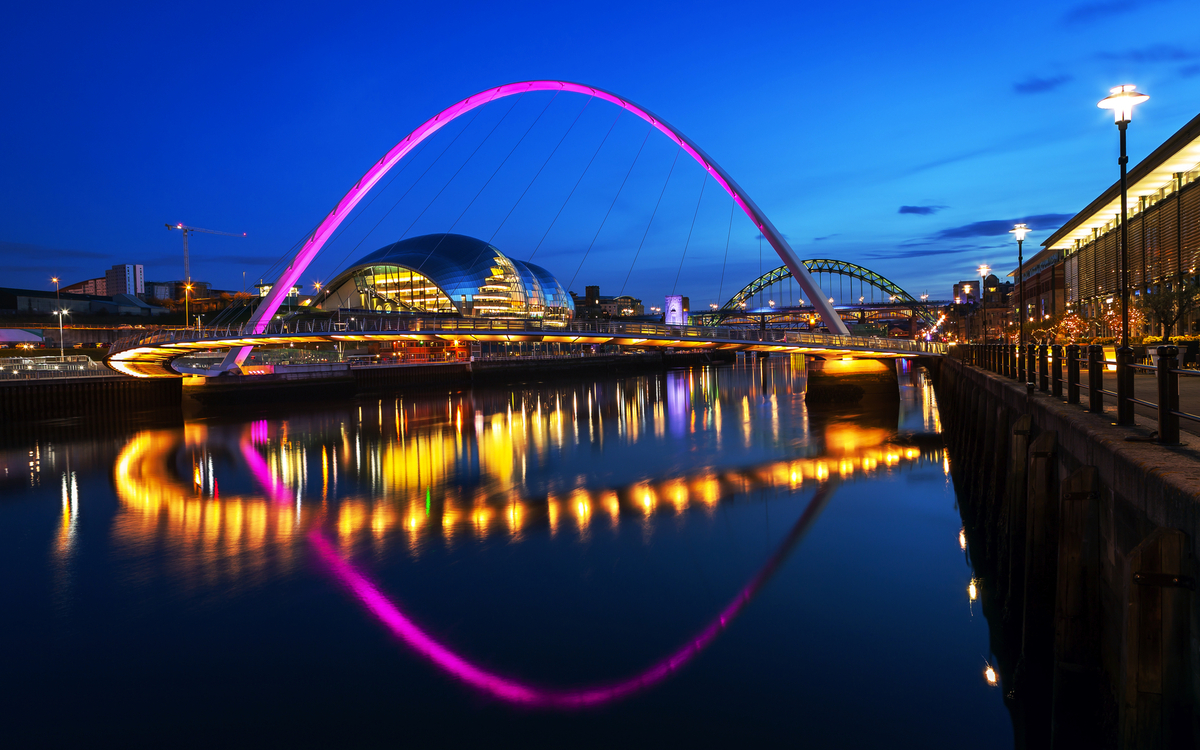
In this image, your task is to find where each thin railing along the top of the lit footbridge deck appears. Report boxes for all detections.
[110,317,947,355]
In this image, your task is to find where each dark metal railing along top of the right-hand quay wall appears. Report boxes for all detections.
[955,343,1200,445]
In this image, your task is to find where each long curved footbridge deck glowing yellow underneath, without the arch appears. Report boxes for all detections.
[106,317,946,377]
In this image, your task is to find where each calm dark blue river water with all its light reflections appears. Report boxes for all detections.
[0,360,1012,748]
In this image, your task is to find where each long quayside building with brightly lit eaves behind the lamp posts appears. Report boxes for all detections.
[1032,109,1200,335]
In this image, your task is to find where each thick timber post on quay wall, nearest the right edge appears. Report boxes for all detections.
[1120,528,1196,749]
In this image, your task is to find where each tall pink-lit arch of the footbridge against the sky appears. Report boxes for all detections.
[222,80,850,370]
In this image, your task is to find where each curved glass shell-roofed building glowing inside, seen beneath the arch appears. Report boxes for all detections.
[311,234,575,325]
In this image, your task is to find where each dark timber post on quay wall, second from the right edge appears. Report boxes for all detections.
[1050,466,1103,749]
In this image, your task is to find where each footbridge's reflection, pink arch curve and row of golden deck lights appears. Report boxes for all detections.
[114,404,936,708]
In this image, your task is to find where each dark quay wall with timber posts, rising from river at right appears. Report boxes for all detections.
[934,359,1200,748]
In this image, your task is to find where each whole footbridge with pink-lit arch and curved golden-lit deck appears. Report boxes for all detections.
[106,80,944,377]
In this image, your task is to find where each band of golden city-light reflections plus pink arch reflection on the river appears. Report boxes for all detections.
[79,362,944,708]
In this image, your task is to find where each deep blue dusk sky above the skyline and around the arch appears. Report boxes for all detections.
[0,0,1200,308]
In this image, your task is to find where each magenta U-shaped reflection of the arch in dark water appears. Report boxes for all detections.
[241,442,833,708]
